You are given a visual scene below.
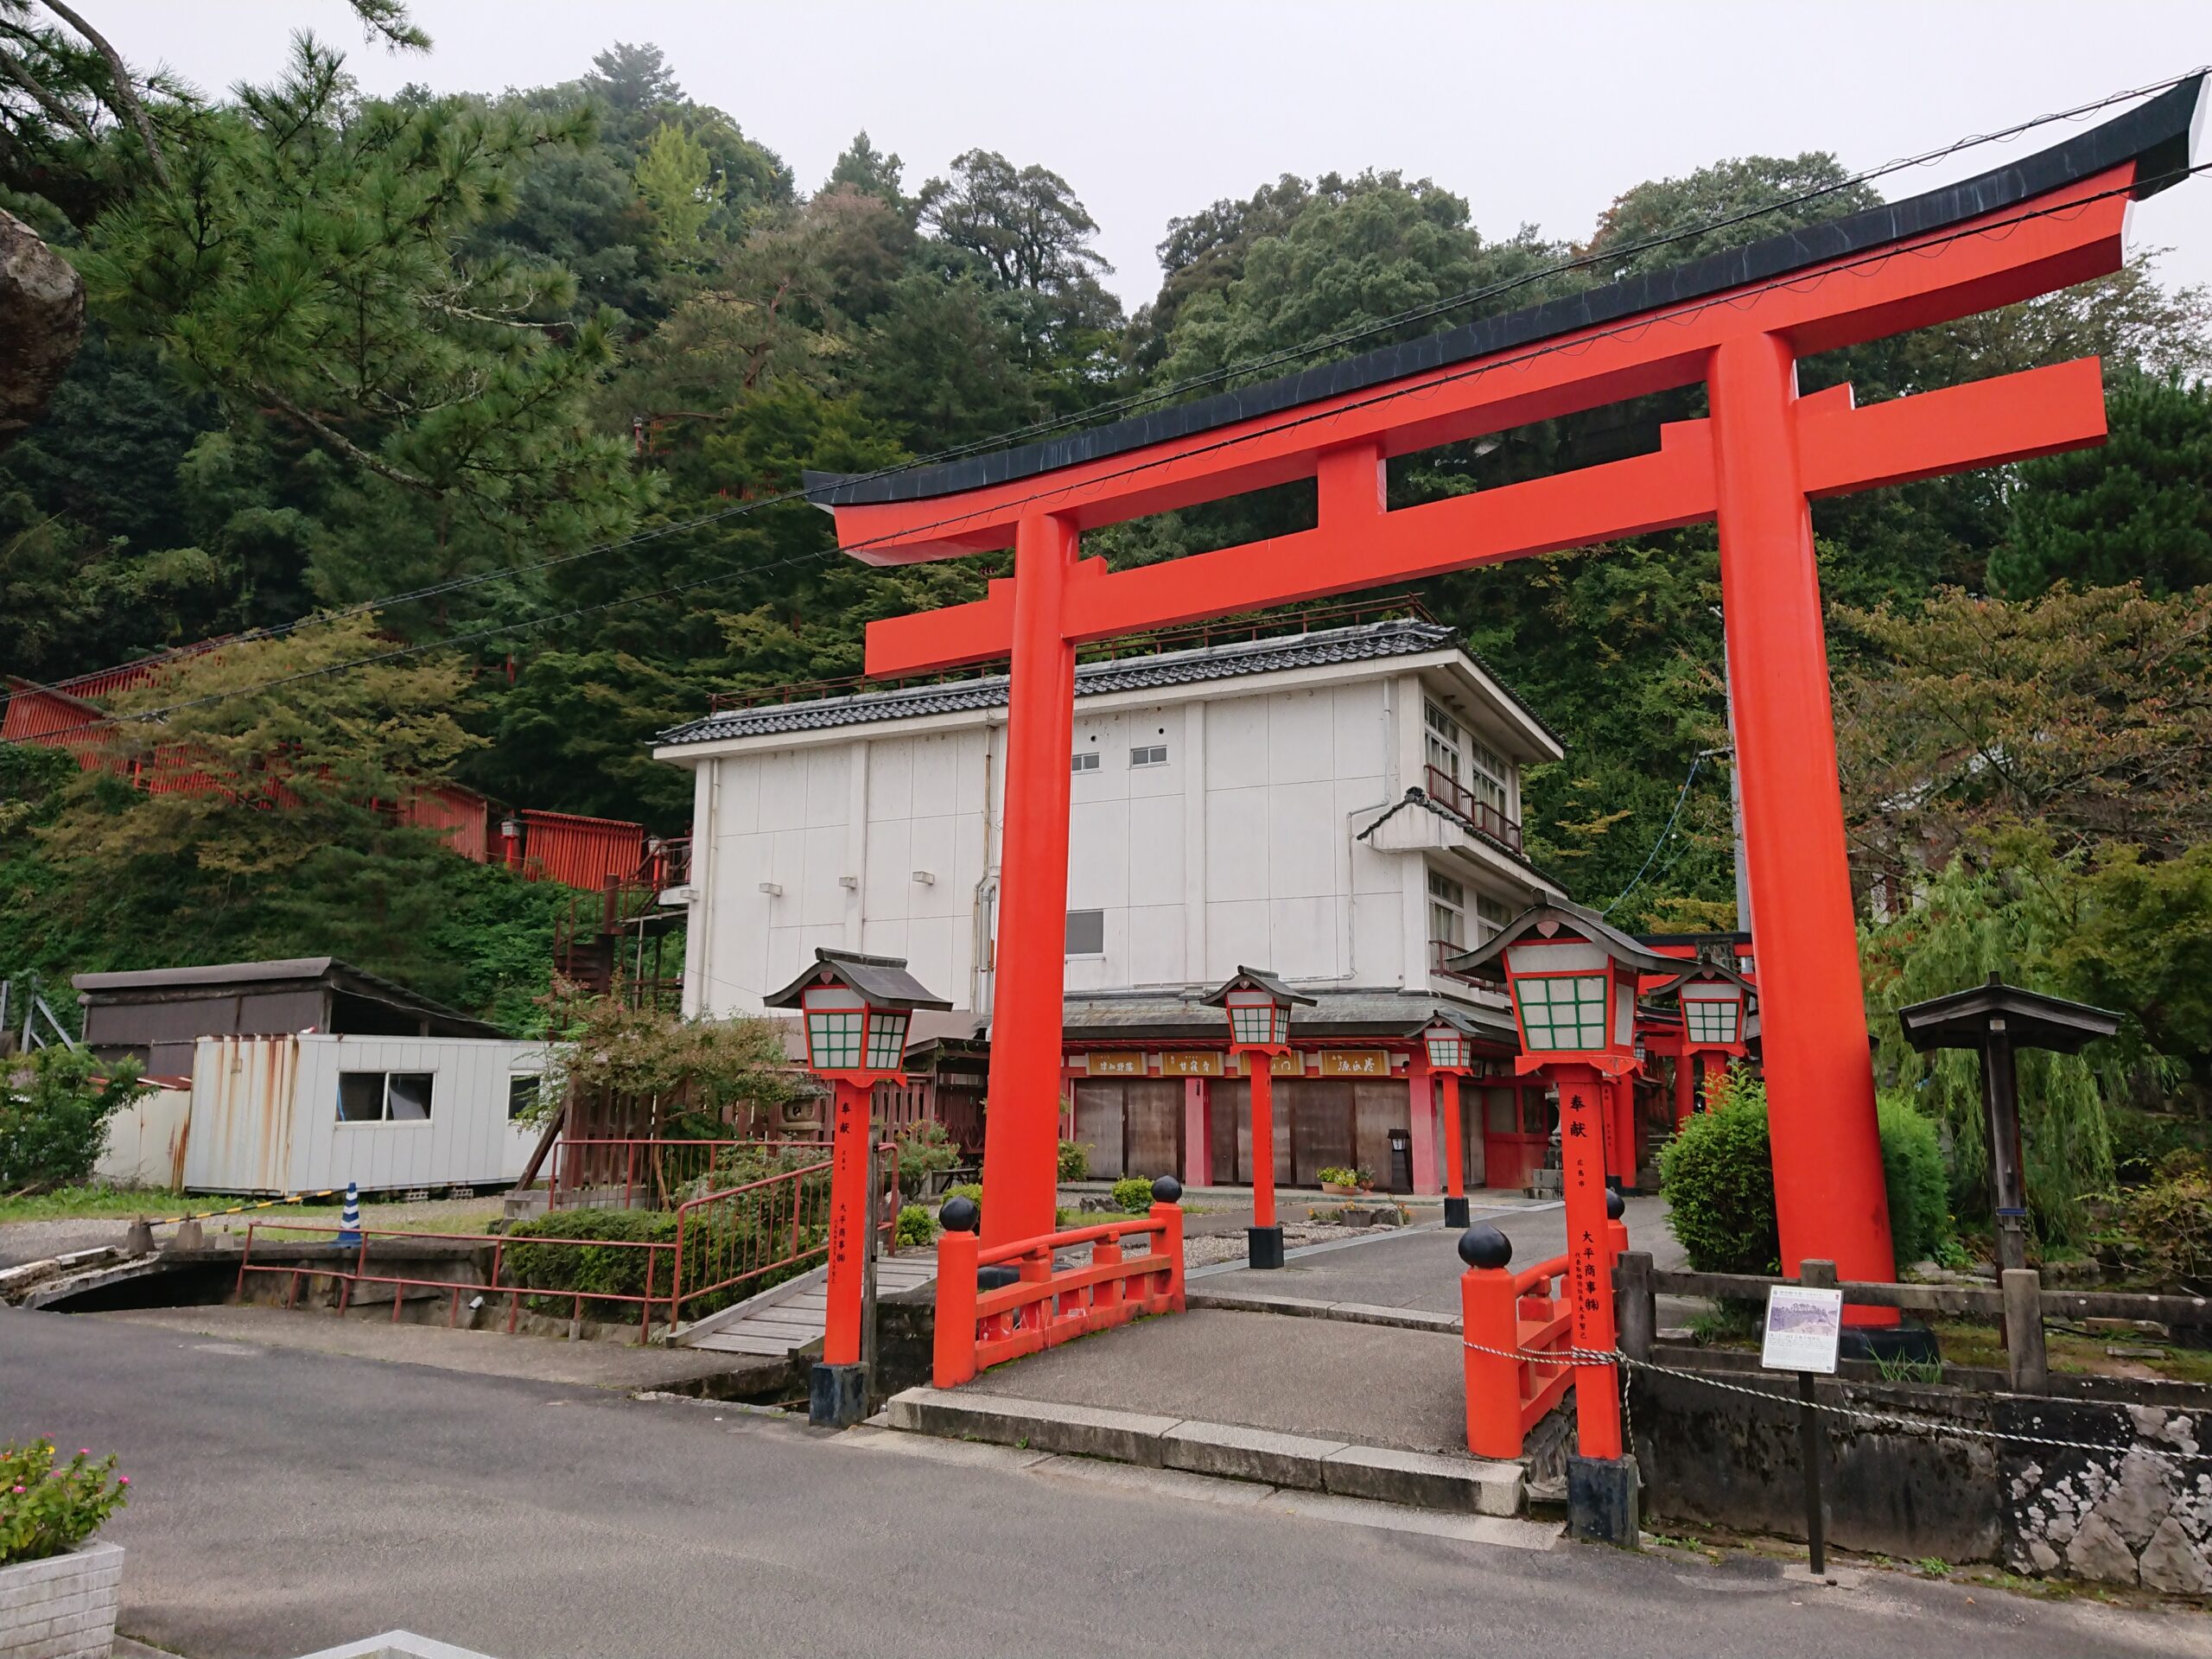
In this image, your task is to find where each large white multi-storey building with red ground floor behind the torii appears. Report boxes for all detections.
[655,620,1564,1188]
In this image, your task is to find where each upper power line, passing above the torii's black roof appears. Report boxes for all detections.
[29,68,2205,695]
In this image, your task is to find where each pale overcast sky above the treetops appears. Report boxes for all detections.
[95,0,2212,305]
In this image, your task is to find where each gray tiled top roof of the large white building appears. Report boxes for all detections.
[657,617,1557,743]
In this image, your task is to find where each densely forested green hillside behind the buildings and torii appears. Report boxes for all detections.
[0,13,2212,1185]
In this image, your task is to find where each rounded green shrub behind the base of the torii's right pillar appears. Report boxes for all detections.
[1659,1071,1951,1274]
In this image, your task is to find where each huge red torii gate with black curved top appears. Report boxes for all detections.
[807,78,2203,1281]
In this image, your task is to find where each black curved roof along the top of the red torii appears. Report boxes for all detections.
[805,71,2205,506]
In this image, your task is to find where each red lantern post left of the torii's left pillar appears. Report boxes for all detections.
[763,949,951,1429]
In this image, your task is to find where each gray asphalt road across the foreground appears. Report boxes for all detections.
[0,1312,2212,1659]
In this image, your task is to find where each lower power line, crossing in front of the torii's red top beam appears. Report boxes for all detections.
[42,162,2212,747]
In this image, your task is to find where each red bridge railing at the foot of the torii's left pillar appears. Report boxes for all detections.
[931,1204,1184,1389]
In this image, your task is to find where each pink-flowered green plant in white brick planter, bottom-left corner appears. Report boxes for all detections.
[0,1438,130,1659]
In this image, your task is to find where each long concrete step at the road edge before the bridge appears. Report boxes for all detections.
[885,1389,1526,1516]
